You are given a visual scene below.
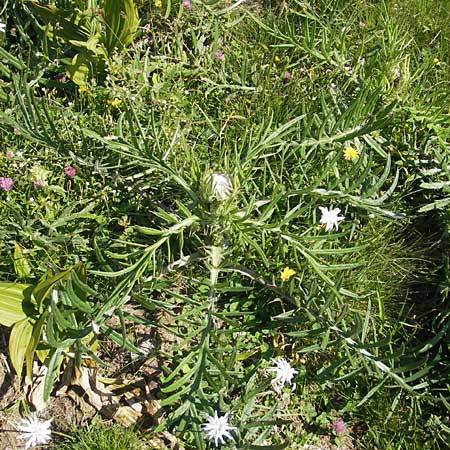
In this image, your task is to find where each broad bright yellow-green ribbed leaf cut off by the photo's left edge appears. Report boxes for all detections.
[0,282,31,327]
